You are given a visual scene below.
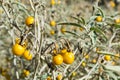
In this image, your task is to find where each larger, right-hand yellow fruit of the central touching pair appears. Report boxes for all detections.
[63,52,75,64]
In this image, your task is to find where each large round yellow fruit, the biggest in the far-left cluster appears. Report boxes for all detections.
[12,44,25,56]
